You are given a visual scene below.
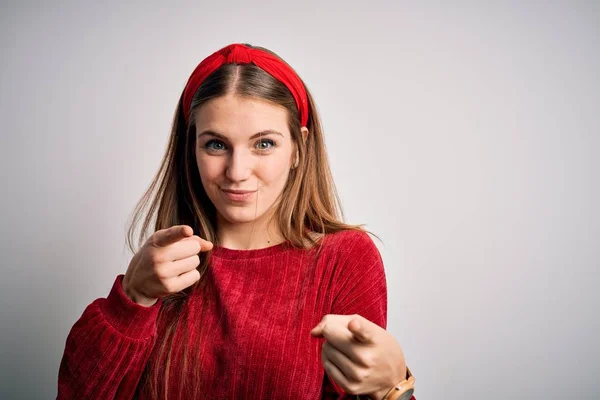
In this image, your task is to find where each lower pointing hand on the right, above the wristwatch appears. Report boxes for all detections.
[310,314,406,400]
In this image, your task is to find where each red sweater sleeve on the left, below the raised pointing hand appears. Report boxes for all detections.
[57,274,162,399]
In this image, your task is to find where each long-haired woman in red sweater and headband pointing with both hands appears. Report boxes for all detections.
[58,44,414,400]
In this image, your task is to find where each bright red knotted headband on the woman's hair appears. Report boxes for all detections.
[183,43,308,126]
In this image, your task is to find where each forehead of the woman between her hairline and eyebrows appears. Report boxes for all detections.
[194,95,290,137]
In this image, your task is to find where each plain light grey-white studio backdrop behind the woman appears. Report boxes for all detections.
[0,1,600,400]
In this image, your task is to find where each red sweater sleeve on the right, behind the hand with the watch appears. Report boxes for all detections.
[323,231,416,400]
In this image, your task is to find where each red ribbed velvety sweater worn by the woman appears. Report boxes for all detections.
[57,231,414,400]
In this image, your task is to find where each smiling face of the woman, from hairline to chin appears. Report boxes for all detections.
[194,95,296,224]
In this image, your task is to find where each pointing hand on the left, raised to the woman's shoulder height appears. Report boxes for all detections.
[122,225,213,307]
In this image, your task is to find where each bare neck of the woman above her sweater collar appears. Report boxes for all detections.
[217,215,285,250]
